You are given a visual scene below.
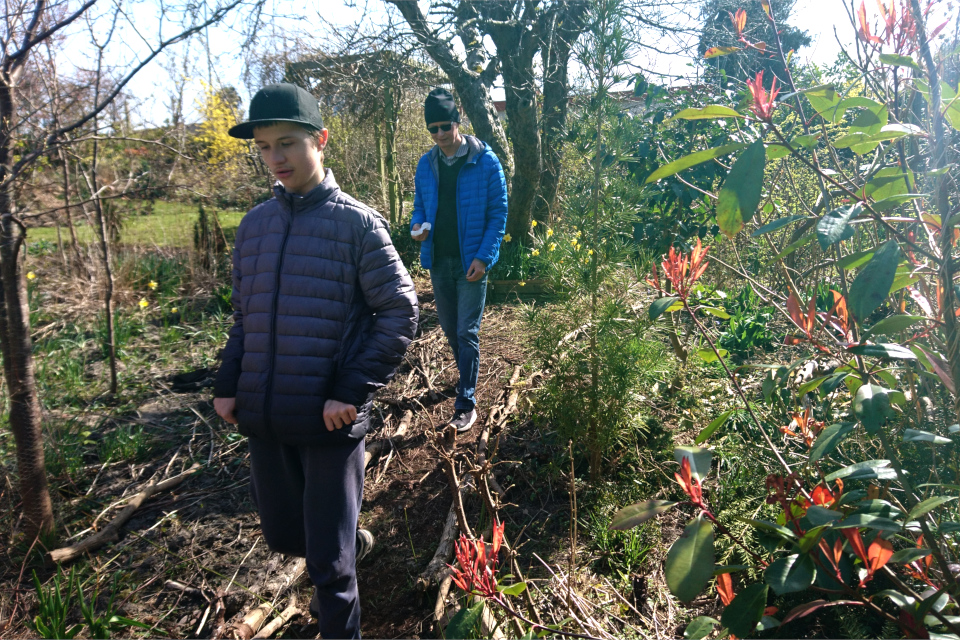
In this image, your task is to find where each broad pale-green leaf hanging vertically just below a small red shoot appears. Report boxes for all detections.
[664,514,712,604]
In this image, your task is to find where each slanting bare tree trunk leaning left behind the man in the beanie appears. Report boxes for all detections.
[386,0,513,181]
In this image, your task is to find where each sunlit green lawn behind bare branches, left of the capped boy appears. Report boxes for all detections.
[27,201,245,248]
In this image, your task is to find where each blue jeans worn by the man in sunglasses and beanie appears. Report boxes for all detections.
[430,257,487,411]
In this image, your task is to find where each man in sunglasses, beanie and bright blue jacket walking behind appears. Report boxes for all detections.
[410,89,507,432]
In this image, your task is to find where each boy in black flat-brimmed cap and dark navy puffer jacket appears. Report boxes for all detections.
[214,83,418,638]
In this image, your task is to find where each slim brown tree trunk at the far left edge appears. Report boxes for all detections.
[0,74,54,539]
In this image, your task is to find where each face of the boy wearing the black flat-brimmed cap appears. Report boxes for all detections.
[253,122,327,196]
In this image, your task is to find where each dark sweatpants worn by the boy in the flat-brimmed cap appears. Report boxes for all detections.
[250,438,364,639]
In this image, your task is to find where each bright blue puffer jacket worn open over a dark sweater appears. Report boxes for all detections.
[410,136,507,273]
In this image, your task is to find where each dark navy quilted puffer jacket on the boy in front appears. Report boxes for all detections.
[214,169,419,445]
